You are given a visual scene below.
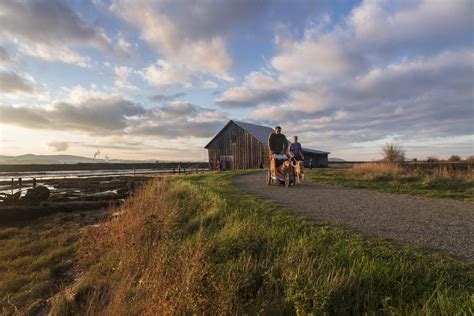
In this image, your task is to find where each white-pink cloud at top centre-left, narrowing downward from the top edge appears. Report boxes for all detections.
[110,0,267,80]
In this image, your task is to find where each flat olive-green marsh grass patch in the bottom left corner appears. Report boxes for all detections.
[0,219,79,315]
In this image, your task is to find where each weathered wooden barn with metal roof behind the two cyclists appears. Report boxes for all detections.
[204,120,329,169]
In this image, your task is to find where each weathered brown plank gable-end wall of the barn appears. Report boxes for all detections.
[207,123,268,169]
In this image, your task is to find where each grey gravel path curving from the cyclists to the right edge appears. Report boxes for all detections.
[233,173,474,261]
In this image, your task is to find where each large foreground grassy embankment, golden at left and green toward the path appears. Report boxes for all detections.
[47,173,474,315]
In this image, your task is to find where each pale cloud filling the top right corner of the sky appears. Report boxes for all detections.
[348,0,472,50]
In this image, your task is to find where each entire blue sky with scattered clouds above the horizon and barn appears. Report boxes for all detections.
[0,0,474,161]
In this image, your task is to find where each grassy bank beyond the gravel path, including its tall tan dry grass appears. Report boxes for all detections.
[306,163,474,202]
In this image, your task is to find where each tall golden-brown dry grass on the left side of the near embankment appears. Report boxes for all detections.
[53,180,212,315]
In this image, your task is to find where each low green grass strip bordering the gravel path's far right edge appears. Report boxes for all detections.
[305,168,474,202]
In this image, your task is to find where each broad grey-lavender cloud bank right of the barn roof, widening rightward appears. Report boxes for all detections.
[249,51,474,143]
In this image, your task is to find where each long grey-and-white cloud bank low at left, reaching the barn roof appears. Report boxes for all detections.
[0,87,227,139]
